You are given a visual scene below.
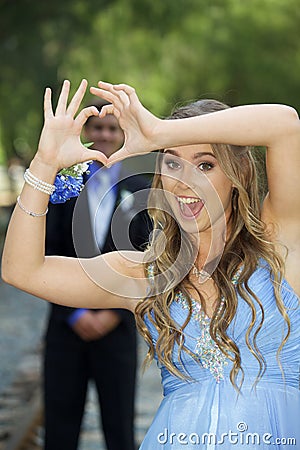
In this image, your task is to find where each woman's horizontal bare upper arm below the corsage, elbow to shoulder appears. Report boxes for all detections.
[3,250,146,310]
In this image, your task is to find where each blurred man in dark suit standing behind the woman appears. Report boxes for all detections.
[44,100,150,450]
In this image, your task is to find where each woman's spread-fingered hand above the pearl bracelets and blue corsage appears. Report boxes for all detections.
[35,80,107,171]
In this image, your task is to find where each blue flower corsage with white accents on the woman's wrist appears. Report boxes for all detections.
[50,161,92,203]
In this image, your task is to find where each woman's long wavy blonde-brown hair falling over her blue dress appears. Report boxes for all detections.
[135,100,290,390]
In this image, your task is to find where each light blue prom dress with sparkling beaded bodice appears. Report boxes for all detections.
[140,261,300,450]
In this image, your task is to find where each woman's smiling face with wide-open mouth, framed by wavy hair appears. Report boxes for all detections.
[161,144,233,233]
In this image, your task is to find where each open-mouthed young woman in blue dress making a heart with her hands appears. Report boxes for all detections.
[2,81,300,450]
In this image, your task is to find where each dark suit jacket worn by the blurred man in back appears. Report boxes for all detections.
[46,169,151,340]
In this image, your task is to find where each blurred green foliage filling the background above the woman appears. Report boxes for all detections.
[0,0,300,160]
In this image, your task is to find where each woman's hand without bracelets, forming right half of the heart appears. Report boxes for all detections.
[90,81,162,163]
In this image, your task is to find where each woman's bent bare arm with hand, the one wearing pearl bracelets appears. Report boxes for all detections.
[2,81,144,309]
